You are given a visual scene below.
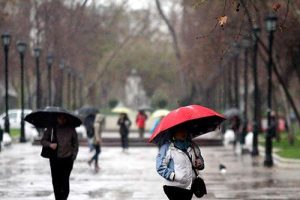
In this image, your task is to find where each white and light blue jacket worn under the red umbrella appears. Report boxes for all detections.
[156,143,204,189]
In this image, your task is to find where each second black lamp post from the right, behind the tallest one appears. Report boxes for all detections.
[251,26,260,156]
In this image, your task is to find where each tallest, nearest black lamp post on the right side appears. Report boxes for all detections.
[264,15,277,167]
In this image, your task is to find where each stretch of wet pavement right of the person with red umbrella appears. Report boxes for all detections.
[203,148,300,199]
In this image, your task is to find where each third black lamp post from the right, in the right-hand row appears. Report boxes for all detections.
[241,38,250,152]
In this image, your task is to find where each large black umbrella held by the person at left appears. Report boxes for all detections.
[24,107,81,128]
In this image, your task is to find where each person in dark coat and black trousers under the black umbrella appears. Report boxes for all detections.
[41,115,78,200]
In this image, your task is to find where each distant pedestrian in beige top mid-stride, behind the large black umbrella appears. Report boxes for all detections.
[88,114,105,172]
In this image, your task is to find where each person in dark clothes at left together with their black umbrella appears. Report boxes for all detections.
[25,107,81,200]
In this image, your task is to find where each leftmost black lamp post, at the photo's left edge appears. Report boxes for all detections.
[1,33,11,133]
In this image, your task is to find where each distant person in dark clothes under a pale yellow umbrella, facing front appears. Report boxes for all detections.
[117,113,131,152]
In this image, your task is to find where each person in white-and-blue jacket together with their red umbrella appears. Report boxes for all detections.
[149,105,225,200]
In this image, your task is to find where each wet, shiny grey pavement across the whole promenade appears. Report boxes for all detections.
[0,143,300,200]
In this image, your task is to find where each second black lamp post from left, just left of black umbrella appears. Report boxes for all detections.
[17,41,27,143]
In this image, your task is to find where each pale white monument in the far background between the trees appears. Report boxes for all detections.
[125,69,150,109]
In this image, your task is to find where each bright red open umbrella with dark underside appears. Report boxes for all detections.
[149,105,225,143]
